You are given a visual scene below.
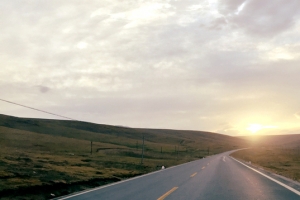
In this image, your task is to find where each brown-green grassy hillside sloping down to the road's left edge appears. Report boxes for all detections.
[0,115,248,199]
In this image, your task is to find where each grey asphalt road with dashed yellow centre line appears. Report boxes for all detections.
[56,152,300,200]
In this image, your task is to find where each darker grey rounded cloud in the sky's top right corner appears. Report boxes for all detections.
[219,0,300,37]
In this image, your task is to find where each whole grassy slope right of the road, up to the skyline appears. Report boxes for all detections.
[232,134,300,184]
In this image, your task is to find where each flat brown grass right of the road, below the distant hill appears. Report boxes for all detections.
[231,146,300,182]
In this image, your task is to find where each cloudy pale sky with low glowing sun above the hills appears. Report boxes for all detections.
[0,0,300,136]
